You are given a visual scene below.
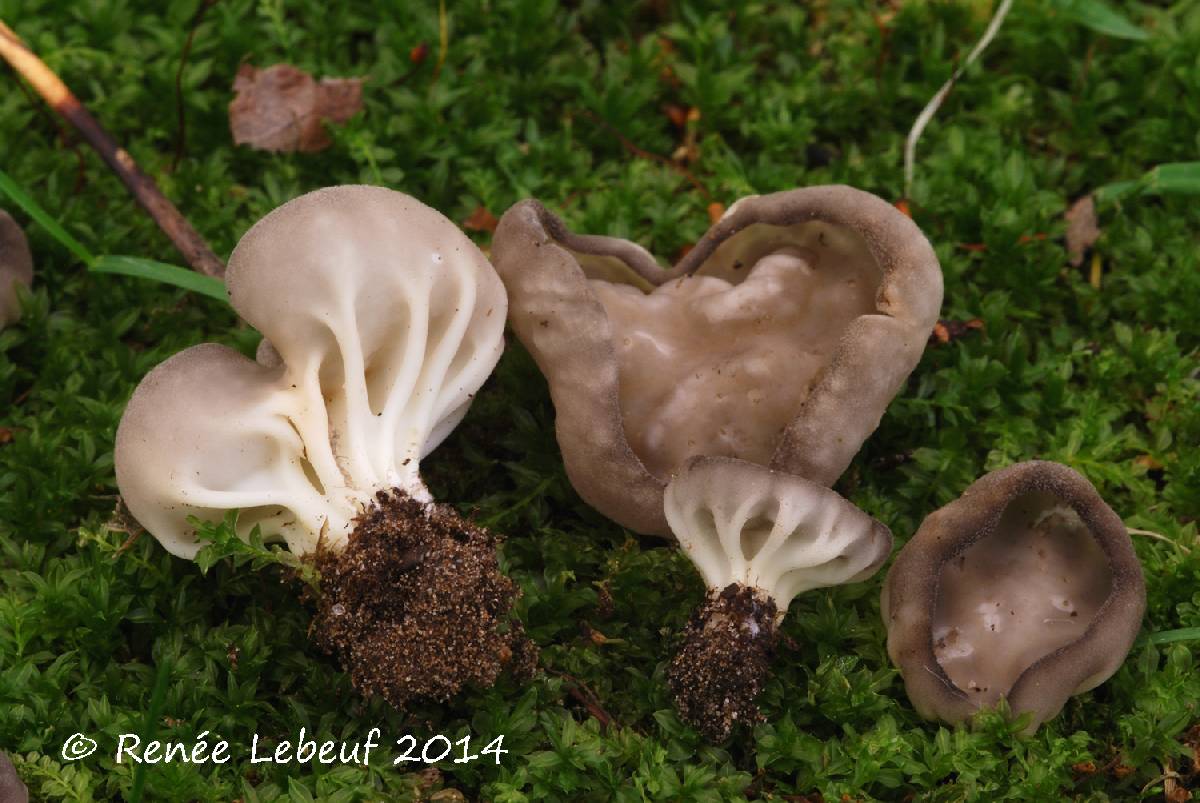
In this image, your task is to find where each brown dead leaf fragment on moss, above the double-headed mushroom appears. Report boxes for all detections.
[229,64,362,152]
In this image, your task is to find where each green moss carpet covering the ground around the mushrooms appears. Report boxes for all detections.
[0,0,1200,801]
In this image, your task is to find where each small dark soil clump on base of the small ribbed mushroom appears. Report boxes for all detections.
[667,583,779,742]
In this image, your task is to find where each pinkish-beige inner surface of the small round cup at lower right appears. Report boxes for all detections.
[934,492,1112,706]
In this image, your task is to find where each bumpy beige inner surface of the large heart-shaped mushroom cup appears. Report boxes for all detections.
[581,222,882,479]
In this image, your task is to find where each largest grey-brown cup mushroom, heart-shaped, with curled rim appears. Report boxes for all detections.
[492,186,942,535]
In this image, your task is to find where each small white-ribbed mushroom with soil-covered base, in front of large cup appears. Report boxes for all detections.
[665,457,892,742]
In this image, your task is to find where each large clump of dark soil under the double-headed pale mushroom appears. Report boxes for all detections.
[313,491,538,708]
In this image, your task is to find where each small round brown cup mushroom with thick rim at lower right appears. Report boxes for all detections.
[882,461,1146,732]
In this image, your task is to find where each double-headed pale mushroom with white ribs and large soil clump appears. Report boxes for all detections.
[115,186,534,706]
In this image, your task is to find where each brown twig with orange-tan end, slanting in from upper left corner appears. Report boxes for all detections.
[0,20,224,277]
